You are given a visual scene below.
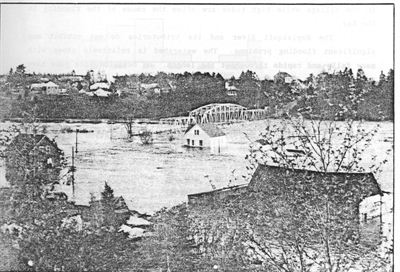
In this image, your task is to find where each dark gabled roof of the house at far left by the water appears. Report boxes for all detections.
[6,133,61,152]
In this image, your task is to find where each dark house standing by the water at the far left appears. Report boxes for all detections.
[5,134,63,184]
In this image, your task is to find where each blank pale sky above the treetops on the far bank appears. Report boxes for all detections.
[0,4,393,79]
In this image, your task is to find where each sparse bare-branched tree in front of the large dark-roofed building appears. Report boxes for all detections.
[241,117,392,272]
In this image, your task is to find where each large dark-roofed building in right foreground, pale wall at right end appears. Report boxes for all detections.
[188,165,392,249]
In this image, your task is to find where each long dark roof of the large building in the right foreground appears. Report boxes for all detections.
[249,165,382,200]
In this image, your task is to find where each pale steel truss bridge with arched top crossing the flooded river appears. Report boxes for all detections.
[160,103,267,127]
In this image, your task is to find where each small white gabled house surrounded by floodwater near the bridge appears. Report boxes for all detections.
[184,124,226,153]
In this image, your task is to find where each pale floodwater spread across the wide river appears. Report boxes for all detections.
[0,120,393,213]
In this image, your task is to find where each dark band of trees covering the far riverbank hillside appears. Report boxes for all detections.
[1,65,394,121]
